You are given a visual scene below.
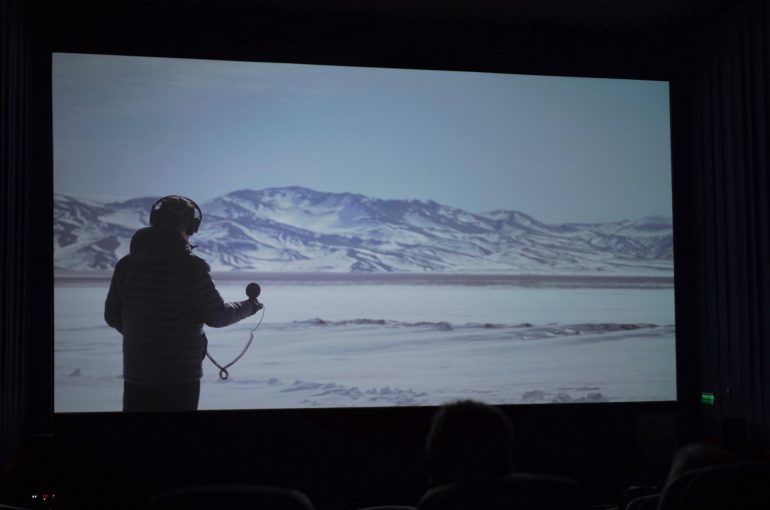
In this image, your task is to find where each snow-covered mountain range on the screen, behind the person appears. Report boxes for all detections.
[54,187,673,276]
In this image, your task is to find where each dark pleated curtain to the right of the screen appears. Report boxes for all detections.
[690,0,770,444]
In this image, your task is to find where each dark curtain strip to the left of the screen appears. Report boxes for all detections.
[0,0,53,464]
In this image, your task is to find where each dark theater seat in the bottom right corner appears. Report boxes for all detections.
[658,463,770,510]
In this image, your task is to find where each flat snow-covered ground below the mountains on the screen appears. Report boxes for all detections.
[54,277,676,412]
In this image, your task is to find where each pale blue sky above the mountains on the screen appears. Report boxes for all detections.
[53,53,671,222]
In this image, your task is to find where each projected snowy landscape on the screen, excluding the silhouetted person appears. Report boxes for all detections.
[52,53,676,412]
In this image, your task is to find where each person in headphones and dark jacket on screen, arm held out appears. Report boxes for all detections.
[104,195,262,412]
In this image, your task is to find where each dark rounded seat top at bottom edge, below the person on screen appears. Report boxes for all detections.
[142,485,314,510]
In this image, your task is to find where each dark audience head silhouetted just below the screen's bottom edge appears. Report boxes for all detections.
[426,400,513,486]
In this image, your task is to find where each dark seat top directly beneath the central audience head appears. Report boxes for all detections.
[417,473,589,510]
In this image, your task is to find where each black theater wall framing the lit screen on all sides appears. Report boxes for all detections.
[0,0,770,509]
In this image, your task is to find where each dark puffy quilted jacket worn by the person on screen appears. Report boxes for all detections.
[104,228,254,384]
